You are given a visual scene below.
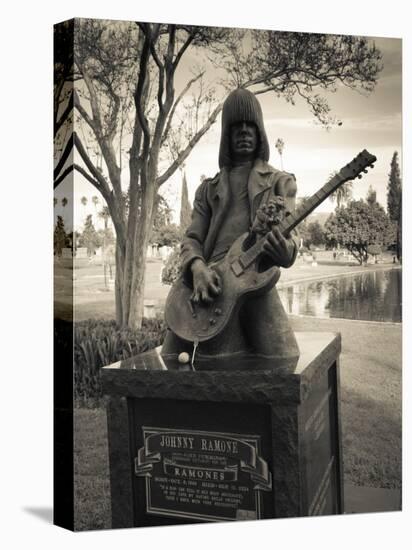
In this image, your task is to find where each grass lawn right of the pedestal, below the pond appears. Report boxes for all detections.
[291,317,402,488]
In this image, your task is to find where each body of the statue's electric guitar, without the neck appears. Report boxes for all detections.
[165,233,280,342]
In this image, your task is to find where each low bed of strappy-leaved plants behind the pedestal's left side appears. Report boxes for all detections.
[74,319,166,404]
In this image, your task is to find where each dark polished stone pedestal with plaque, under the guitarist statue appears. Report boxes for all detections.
[102,332,343,528]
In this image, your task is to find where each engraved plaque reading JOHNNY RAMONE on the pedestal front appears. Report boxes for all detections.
[135,427,272,521]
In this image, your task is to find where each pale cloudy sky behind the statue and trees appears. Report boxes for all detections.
[55,30,402,228]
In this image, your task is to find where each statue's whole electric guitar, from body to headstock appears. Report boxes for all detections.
[165,149,376,343]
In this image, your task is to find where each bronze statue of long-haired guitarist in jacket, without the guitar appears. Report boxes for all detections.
[162,89,299,361]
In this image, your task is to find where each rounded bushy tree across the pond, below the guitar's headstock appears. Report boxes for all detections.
[325,200,391,265]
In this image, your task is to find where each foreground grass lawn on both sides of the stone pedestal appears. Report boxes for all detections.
[75,317,402,530]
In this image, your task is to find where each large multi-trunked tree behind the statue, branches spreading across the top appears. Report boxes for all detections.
[54,20,381,327]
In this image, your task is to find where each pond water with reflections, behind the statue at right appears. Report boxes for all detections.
[279,269,402,323]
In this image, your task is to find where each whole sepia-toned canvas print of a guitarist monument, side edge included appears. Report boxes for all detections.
[50,18,402,531]
